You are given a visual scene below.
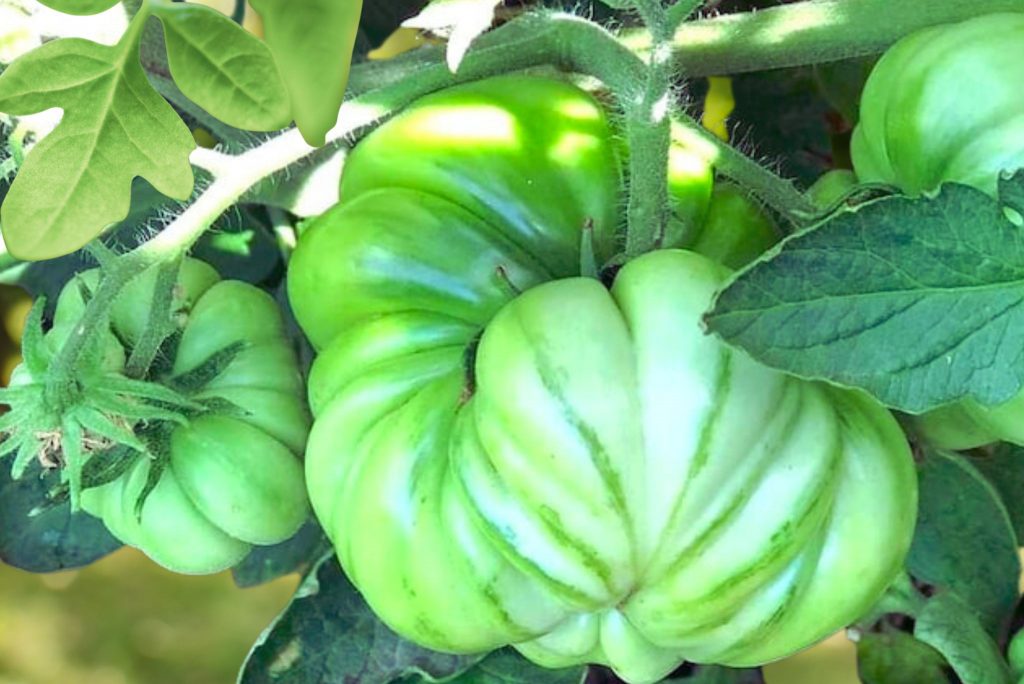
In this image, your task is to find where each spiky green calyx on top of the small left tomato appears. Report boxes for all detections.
[0,284,246,515]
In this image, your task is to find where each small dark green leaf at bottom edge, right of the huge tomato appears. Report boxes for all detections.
[857,630,949,684]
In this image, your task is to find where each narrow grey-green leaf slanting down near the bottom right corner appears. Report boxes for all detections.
[913,593,1011,684]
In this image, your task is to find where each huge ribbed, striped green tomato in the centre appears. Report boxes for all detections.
[289,77,916,682]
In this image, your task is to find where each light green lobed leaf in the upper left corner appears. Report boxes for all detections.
[0,39,196,260]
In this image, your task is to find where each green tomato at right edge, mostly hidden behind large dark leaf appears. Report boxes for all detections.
[852,13,1024,448]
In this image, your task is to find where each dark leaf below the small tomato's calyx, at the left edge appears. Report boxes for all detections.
[0,466,121,572]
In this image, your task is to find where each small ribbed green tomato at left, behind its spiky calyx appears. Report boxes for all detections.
[39,259,309,573]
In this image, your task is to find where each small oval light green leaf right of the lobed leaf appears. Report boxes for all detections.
[153,0,292,131]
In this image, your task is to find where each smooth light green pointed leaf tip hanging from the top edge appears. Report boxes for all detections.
[250,0,362,146]
